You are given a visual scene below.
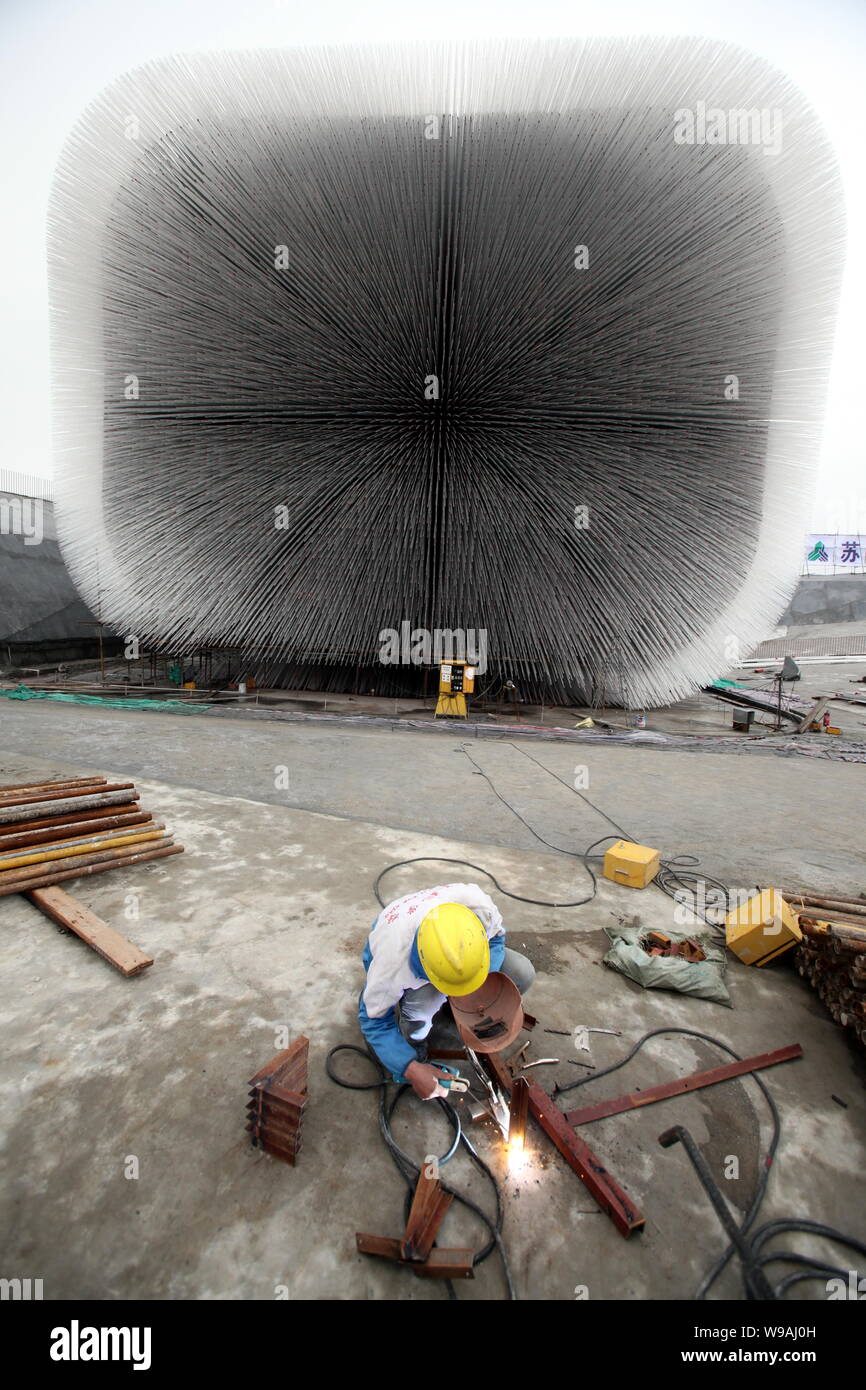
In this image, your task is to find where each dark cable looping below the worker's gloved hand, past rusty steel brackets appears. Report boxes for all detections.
[325,1043,517,1300]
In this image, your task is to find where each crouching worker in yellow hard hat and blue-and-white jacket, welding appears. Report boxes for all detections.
[359,883,535,1101]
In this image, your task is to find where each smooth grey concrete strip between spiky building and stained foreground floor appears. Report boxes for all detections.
[0,701,866,897]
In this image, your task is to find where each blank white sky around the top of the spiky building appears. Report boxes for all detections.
[0,0,866,531]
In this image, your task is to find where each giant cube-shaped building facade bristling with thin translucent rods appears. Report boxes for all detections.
[50,39,842,705]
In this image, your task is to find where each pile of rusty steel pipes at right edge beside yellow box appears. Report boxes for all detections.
[792,898,866,1045]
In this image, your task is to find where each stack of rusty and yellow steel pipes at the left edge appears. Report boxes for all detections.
[0,777,183,897]
